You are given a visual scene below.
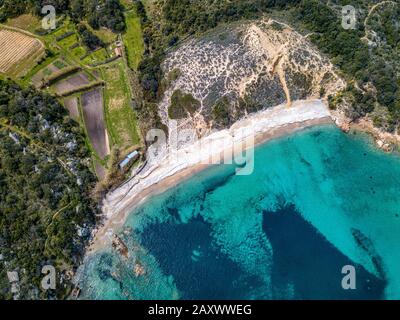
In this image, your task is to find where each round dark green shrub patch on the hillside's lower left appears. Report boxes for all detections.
[168,90,200,119]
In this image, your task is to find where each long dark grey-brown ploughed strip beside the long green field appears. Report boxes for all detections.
[81,89,109,159]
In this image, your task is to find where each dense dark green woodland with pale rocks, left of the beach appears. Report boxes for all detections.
[0,80,96,298]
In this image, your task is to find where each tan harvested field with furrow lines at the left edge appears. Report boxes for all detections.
[0,29,44,76]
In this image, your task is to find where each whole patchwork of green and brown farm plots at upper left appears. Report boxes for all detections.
[0,13,144,179]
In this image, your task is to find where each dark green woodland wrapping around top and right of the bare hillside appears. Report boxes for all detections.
[136,0,400,132]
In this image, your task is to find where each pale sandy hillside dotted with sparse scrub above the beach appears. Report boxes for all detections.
[160,19,345,145]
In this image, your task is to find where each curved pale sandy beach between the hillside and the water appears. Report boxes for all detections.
[88,100,333,254]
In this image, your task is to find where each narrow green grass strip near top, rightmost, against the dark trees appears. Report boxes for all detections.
[122,10,144,70]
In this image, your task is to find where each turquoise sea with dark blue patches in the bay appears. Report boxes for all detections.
[80,125,400,299]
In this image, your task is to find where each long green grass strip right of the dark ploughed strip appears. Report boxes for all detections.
[101,60,140,150]
